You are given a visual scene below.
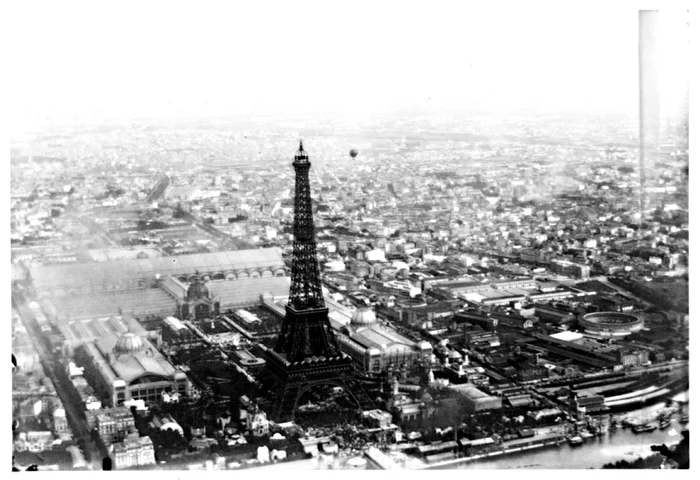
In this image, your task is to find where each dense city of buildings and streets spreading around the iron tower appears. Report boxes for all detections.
[11,107,689,470]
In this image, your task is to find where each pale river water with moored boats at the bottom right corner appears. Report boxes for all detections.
[451,403,690,470]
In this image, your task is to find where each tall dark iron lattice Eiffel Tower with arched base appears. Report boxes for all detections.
[263,142,374,422]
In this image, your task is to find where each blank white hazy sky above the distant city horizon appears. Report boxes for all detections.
[5,0,687,128]
